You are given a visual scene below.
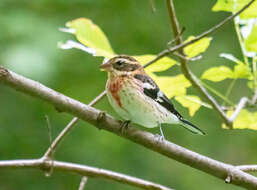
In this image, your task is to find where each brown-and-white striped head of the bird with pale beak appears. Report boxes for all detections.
[100,55,143,76]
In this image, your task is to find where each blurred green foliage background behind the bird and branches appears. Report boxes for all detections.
[0,0,257,190]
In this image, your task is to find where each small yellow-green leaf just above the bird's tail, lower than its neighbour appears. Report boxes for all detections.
[175,95,201,116]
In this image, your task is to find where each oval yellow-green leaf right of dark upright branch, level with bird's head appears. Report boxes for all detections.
[201,66,234,82]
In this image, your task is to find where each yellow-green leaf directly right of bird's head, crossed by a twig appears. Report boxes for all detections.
[134,55,177,72]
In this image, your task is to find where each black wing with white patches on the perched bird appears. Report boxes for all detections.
[134,74,183,120]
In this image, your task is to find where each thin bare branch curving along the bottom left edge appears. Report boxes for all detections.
[0,159,171,190]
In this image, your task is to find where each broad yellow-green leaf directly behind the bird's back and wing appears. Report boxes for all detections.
[148,73,191,98]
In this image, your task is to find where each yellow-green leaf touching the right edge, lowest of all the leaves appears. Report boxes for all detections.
[223,109,257,130]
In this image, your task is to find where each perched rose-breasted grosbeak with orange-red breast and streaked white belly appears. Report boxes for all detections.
[101,55,204,138]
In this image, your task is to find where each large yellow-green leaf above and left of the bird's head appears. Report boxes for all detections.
[67,18,115,58]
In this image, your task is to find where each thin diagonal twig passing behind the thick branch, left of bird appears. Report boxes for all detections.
[43,91,106,159]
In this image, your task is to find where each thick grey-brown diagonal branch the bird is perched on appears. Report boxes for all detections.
[0,67,257,189]
